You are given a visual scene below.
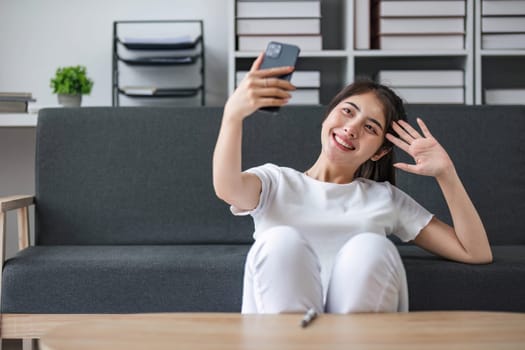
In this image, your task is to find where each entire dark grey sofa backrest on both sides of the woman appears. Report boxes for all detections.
[35,105,525,245]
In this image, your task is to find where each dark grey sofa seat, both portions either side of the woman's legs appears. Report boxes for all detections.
[2,245,525,313]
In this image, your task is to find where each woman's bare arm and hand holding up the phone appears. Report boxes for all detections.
[213,54,294,210]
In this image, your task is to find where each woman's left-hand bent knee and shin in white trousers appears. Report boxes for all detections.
[243,226,323,313]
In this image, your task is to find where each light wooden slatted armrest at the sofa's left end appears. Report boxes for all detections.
[0,195,35,258]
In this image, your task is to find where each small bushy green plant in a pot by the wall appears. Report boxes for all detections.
[50,66,93,107]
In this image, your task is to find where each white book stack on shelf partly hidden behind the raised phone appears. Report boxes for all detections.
[235,70,321,105]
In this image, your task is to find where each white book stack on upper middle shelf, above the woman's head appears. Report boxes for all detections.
[370,0,466,50]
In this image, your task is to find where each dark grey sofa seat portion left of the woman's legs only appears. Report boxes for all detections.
[1,245,249,313]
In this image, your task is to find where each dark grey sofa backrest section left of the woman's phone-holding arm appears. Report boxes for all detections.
[35,107,253,245]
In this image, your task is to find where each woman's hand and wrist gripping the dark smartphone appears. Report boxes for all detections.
[224,53,295,119]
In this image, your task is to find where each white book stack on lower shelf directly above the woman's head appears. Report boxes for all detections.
[377,70,465,103]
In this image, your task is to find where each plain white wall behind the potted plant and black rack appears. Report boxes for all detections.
[0,0,229,106]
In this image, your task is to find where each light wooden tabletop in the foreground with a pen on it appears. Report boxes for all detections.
[40,312,525,350]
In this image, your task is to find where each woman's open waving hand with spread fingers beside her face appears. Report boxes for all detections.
[386,118,454,178]
